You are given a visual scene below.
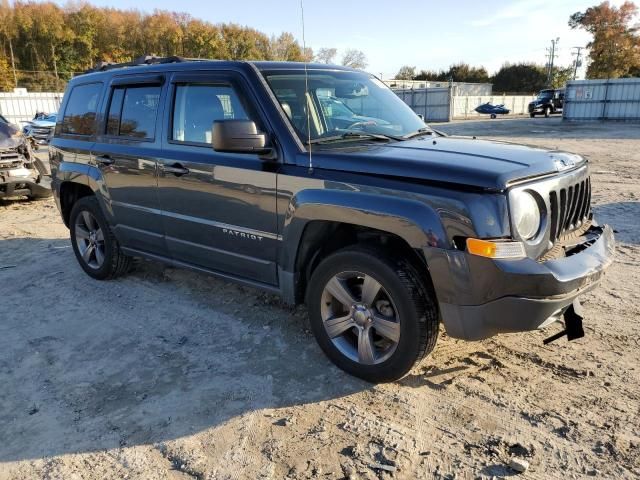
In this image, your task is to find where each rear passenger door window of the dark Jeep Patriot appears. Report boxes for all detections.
[106,85,161,140]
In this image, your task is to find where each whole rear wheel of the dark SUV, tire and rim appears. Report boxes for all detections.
[69,196,131,280]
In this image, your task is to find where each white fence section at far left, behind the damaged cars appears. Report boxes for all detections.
[0,88,64,125]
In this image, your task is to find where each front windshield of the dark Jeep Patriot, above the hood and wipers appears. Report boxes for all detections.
[264,70,426,143]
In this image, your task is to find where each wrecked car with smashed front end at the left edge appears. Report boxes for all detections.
[0,122,51,200]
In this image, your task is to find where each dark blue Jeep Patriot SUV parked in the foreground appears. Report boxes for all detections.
[49,58,614,382]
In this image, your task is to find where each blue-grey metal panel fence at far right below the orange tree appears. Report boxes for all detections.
[562,78,640,121]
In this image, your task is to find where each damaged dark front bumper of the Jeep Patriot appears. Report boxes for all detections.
[428,225,615,340]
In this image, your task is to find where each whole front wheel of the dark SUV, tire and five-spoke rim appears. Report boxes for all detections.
[307,248,439,382]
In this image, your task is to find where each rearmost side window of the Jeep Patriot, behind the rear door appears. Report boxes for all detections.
[61,83,102,135]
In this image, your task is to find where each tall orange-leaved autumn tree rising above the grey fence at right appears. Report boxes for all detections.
[569,1,640,78]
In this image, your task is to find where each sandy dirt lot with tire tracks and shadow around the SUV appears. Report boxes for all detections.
[0,118,640,480]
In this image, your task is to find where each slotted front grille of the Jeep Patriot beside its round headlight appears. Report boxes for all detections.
[549,177,591,243]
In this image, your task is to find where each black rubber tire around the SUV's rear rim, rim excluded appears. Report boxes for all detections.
[69,196,132,280]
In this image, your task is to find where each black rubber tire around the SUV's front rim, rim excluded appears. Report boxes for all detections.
[307,247,440,383]
